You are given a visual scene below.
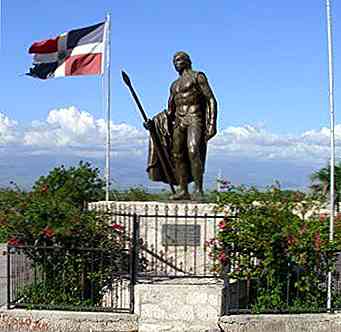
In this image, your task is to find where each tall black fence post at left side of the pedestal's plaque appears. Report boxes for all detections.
[130,213,140,314]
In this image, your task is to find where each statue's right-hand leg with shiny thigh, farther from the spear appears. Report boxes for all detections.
[187,122,205,199]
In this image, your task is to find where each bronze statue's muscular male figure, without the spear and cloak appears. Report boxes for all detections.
[167,52,217,200]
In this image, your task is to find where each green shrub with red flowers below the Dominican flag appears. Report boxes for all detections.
[0,163,133,305]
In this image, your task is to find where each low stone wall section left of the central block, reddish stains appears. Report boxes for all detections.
[0,309,138,332]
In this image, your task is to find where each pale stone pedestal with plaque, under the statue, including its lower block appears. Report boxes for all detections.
[89,202,223,332]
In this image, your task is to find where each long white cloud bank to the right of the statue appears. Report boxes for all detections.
[210,125,341,162]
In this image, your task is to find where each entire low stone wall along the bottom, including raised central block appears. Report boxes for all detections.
[4,310,341,332]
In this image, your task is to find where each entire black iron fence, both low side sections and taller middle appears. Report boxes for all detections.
[7,205,341,315]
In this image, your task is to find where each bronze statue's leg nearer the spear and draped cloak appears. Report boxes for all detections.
[171,126,190,200]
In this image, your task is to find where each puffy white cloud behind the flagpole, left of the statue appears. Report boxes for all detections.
[19,106,147,154]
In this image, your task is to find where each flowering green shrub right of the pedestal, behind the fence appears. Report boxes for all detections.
[208,186,341,312]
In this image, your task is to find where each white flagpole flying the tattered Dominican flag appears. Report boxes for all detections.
[104,14,111,201]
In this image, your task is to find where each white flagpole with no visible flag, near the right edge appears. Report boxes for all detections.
[326,0,338,311]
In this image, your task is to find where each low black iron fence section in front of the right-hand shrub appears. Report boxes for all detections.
[221,262,341,315]
